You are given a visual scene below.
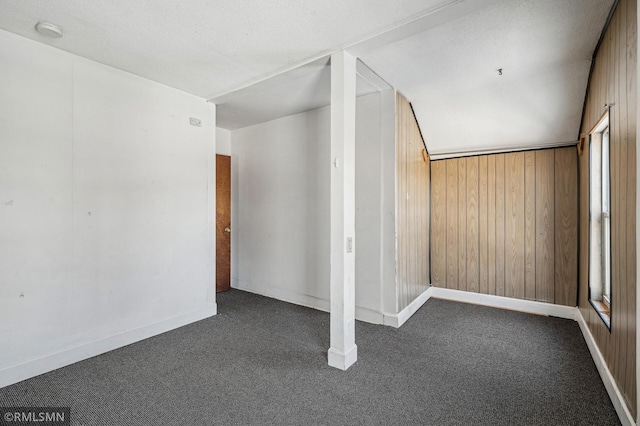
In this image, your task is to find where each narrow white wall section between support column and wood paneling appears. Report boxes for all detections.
[356,90,397,322]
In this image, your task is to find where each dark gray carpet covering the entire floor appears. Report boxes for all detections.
[0,290,620,426]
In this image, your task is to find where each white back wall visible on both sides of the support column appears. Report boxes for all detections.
[231,90,395,323]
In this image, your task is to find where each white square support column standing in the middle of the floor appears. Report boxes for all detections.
[328,51,358,370]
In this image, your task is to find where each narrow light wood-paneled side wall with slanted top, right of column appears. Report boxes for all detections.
[396,93,430,312]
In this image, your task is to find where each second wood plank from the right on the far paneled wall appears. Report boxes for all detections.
[536,149,555,303]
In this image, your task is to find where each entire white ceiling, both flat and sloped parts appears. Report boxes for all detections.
[0,0,614,155]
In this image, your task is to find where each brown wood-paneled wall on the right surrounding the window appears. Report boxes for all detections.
[579,0,637,416]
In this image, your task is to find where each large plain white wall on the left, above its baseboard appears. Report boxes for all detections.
[0,31,215,386]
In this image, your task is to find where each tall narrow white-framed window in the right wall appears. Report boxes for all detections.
[589,111,611,329]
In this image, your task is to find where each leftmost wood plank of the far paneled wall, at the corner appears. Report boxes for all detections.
[431,161,447,287]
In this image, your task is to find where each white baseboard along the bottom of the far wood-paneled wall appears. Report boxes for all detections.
[431,287,578,321]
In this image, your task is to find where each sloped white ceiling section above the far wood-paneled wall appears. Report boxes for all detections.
[362,0,613,155]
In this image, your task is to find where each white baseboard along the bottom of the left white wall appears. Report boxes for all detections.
[0,304,217,388]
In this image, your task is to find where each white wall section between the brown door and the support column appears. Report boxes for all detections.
[231,104,329,309]
